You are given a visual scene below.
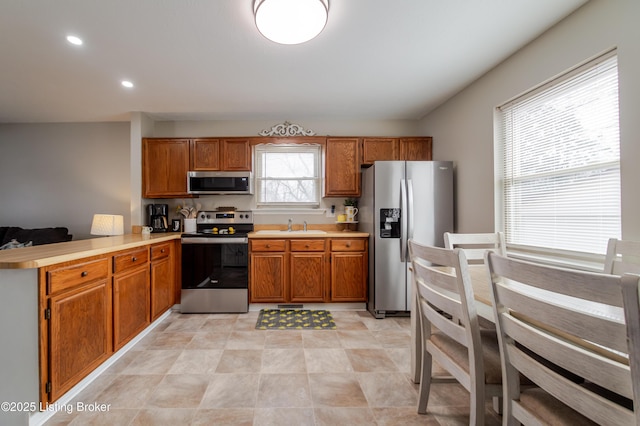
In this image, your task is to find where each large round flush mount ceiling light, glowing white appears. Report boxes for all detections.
[253,0,329,44]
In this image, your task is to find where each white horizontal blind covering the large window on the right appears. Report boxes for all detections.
[498,53,620,253]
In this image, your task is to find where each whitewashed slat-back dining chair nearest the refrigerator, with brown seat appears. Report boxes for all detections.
[409,240,502,425]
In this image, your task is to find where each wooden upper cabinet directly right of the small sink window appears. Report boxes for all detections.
[324,138,360,197]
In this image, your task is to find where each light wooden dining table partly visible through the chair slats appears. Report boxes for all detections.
[411,264,629,383]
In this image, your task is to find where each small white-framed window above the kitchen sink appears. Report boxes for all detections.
[255,145,322,207]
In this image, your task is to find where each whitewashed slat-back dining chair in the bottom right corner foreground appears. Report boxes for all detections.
[486,252,640,425]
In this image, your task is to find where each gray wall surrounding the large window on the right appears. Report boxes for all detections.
[420,0,640,240]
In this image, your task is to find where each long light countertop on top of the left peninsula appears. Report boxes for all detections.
[0,232,181,269]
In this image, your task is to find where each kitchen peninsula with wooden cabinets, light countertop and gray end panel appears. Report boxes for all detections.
[0,233,180,425]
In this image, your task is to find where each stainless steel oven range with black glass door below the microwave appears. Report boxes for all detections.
[180,210,253,313]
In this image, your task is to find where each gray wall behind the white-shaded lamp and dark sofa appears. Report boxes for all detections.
[0,123,131,239]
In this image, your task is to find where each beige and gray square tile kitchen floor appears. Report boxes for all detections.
[46,311,500,426]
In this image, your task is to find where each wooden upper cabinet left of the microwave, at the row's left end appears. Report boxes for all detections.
[142,138,189,198]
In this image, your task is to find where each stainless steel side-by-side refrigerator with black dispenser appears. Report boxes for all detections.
[359,161,453,318]
